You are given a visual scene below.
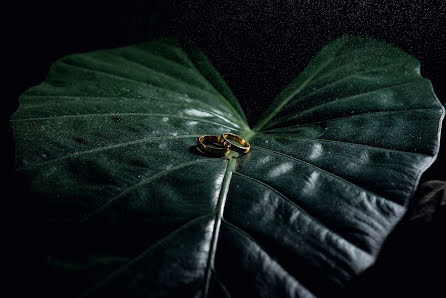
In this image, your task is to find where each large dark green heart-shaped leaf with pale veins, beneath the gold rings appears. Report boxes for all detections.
[11,36,444,297]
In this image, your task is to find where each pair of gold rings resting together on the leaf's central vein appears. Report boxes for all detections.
[197,132,251,155]
